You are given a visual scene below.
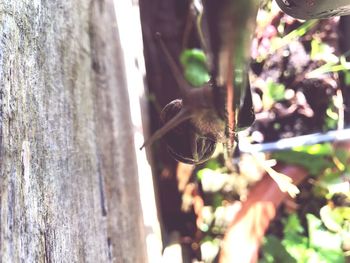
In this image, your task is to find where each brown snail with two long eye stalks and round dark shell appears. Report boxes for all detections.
[141,33,225,164]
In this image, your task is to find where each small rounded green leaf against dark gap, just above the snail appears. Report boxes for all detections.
[180,49,210,87]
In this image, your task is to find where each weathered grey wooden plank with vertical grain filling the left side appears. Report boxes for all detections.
[0,0,146,262]
